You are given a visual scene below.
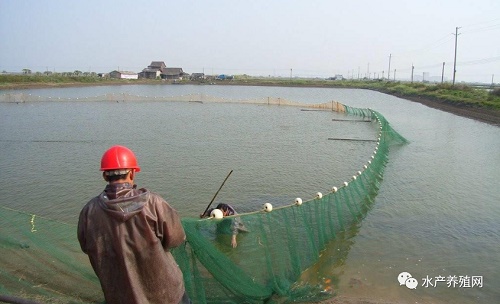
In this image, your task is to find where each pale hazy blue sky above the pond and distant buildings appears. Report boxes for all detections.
[0,0,500,83]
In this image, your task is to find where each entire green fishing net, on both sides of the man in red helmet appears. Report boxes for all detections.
[0,102,406,303]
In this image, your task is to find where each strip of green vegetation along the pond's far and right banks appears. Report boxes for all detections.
[0,70,500,110]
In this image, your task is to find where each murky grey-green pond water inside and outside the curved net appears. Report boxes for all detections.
[0,85,500,303]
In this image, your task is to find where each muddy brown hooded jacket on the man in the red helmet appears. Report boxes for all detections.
[78,184,185,304]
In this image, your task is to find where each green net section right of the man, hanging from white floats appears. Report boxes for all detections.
[174,107,406,303]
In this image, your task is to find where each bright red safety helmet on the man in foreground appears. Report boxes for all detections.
[101,145,141,172]
